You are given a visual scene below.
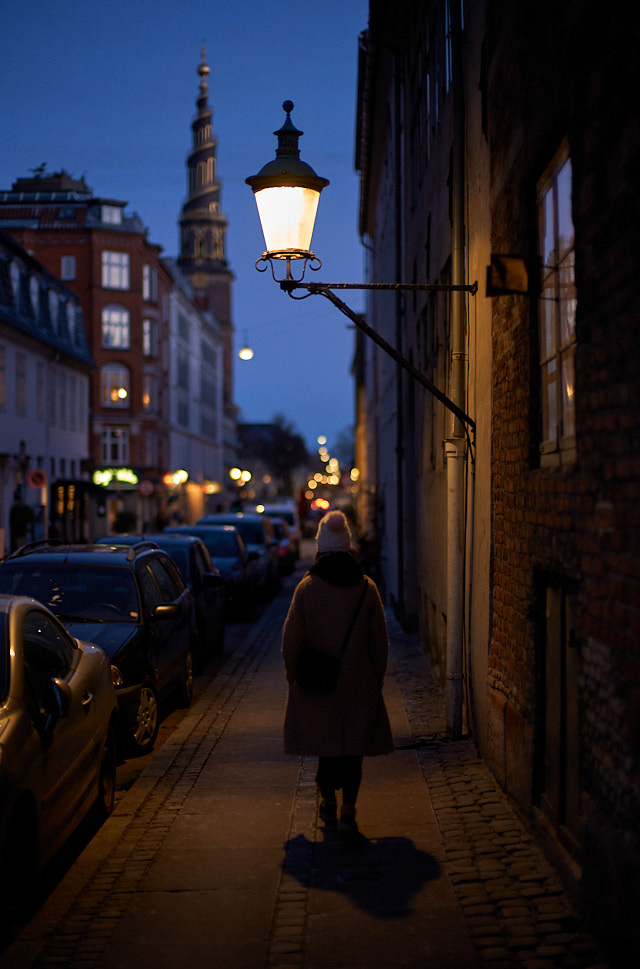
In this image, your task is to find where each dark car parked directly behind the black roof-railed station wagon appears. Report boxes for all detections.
[96,532,227,669]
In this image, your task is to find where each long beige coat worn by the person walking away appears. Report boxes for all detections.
[282,574,393,757]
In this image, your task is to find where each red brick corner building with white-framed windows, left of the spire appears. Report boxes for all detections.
[0,172,173,528]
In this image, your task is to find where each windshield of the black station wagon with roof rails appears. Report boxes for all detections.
[0,561,140,622]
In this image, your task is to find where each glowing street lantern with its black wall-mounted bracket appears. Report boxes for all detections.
[245,101,478,447]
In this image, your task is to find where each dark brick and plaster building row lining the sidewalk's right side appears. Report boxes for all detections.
[356,0,640,966]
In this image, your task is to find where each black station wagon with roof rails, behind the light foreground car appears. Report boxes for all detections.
[0,542,197,753]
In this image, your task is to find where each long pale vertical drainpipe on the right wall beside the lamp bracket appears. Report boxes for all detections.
[445,0,467,739]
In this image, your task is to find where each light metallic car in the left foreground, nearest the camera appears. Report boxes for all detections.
[0,595,118,905]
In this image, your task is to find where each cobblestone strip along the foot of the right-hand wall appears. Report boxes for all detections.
[389,617,607,969]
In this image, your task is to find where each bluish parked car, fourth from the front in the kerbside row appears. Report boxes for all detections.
[163,525,256,617]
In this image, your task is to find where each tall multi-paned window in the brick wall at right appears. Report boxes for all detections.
[538,140,576,464]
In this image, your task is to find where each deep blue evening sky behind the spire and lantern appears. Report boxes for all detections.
[0,0,368,450]
